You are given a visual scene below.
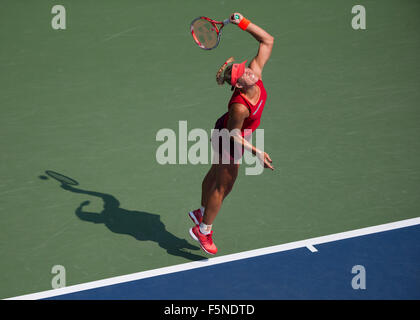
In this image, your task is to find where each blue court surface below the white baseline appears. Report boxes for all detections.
[44,224,420,300]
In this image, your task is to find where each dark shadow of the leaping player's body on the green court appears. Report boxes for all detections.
[61,183,206,261]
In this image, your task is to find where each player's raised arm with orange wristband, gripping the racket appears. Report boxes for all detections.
[230,12,274,79]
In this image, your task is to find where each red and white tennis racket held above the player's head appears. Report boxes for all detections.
[190,17,230,50]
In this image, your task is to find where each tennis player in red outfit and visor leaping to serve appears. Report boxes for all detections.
[189,13,274,254]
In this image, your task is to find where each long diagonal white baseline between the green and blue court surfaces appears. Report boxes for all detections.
[5,217,420,300]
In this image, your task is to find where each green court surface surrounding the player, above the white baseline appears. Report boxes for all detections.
[0,0,420,298]
